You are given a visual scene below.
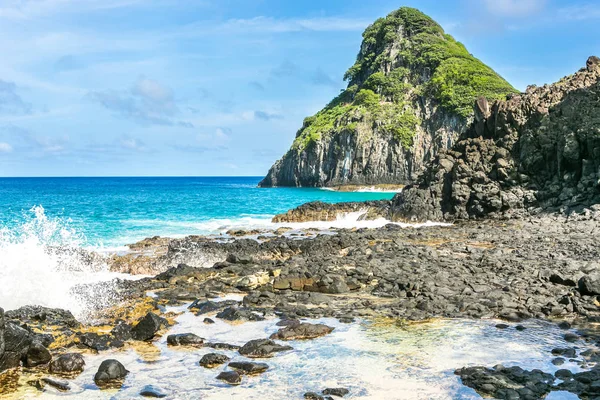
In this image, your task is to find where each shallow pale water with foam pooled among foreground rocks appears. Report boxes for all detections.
[8,296,578,400]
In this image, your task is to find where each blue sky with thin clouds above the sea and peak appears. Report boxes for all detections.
[0,0,600,176]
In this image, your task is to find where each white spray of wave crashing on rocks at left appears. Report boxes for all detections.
[0,206,132,318]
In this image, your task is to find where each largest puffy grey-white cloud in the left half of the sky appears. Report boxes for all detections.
[88,77,194,128]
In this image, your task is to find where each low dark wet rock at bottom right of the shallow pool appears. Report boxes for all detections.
[455,365,554,399]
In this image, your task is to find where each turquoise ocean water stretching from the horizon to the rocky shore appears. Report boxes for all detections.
[0,177,393,246]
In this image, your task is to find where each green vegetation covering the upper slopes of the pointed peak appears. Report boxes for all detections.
[293,7,517,150]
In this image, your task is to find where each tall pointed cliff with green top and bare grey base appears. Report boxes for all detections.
[259,8,516,187]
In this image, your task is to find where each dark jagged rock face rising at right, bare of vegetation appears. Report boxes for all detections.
[392,57,600,221]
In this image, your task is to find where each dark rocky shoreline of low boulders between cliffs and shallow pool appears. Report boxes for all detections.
[0,209,600,399]
